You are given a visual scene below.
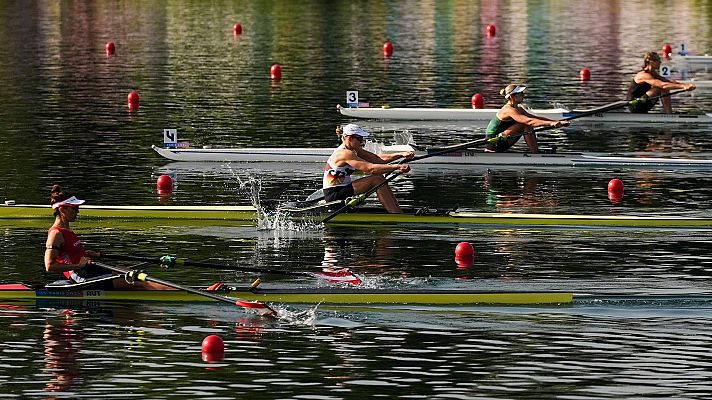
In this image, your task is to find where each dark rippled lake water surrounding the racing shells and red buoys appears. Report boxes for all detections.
[0,1,712,399]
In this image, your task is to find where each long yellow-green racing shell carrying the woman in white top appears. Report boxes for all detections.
[0,204,712,229]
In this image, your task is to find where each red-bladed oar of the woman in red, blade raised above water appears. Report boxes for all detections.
[101,254,363,285]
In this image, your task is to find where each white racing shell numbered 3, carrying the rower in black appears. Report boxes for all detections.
[337,106,712,124]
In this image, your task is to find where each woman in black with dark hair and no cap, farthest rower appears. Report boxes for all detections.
[626,51,696,114]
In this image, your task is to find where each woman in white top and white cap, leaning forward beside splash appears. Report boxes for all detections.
[322,124,414,213]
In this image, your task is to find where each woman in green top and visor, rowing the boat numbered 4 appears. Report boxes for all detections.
[485,84,569,153]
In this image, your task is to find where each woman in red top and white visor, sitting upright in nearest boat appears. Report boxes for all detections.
[44,185,170,290]
